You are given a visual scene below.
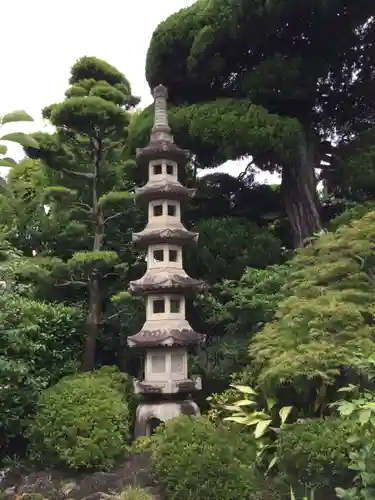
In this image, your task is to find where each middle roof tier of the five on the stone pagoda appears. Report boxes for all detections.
[132,227,198,246]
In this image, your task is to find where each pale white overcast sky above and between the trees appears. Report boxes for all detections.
[0,0,277,183]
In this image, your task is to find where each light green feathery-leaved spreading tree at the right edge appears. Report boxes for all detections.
[249,211,375,415]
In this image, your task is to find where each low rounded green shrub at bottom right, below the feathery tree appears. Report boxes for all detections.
[277,417,353,499]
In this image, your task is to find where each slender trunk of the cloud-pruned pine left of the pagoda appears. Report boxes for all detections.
[81,142,105,371]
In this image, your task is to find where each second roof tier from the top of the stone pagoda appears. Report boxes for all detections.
[135,177,195,202]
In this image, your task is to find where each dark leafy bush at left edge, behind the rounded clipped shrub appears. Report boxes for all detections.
[0,293,82,450]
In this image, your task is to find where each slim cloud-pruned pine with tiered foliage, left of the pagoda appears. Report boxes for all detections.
[27,57,143,370]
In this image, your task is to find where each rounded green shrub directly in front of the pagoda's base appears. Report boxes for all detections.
[147,417,259,500]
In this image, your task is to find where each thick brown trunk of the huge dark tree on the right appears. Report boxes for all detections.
[281,129,322,248]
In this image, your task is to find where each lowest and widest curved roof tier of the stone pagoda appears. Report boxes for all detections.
[127,328,205,347]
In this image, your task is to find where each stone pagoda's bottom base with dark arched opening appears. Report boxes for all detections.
[134,400,201,439]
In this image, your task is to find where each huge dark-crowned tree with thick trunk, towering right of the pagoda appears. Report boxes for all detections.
[134,0,375,247]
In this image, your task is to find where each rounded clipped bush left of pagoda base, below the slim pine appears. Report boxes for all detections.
[28,367,131,469]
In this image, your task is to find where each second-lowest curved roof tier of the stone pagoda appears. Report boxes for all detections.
[129,268,206,294]
